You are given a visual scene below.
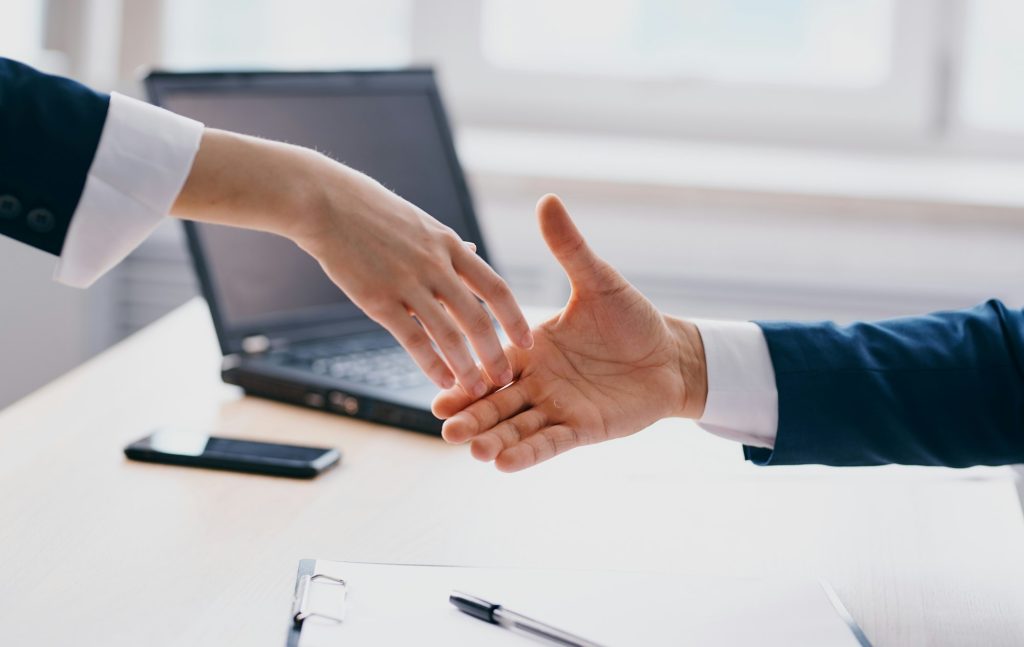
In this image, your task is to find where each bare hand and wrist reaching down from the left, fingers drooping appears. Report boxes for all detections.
[174,129,532,397]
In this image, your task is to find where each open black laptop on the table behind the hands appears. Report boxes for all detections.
[145,70,499,434]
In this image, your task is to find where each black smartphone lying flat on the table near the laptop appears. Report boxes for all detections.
[125,429,341,478]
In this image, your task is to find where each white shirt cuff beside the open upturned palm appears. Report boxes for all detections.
[693,320,778,448]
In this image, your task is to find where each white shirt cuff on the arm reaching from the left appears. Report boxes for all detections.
[53,93,203,288]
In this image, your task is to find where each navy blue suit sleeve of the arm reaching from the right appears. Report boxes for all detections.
[743,301,1024,467]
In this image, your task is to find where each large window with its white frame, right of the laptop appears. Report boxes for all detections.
[414,0,945,146]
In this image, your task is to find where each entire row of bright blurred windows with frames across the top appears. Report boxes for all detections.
[18,0,1024,155]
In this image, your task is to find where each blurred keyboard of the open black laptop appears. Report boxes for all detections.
[286,339,429,389]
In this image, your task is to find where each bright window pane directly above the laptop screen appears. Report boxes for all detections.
[163,0,412,69]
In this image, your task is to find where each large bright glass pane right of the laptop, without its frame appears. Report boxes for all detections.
[481,0,895,87]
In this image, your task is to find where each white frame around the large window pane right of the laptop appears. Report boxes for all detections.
[413,0,945,145]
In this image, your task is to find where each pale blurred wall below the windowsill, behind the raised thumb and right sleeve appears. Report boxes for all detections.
[474,176,1024,320]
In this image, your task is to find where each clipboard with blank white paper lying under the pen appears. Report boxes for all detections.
[286,559,870,647]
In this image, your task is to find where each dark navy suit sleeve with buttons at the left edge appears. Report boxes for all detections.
[0,58,110,255]
